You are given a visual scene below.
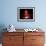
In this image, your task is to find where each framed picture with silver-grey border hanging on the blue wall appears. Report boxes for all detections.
[17,7,35,22]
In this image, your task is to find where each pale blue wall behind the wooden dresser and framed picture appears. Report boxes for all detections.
[0,0,46,31]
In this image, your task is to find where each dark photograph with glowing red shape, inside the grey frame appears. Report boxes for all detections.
[20,9,33,19]
